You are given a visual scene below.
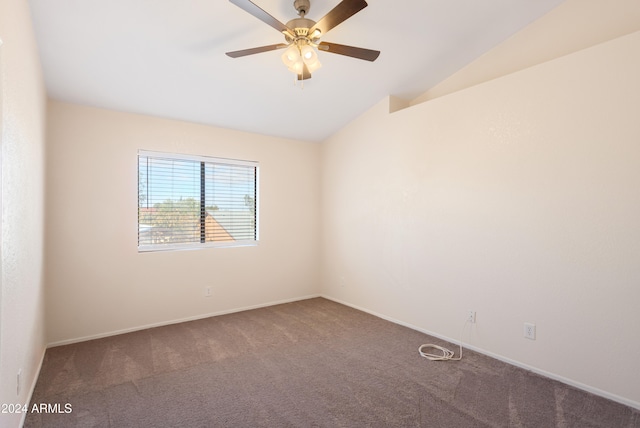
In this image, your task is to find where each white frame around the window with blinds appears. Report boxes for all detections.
[136,150,260,253]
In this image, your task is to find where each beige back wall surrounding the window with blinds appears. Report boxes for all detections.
[46,102,320,343]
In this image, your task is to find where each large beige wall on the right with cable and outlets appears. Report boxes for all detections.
[322,33,640,408]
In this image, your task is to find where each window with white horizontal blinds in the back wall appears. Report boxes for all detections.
[138,151,258,251]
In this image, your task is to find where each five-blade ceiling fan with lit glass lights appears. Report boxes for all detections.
[227,0,380,80]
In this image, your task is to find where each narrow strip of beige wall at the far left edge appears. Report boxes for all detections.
[0,0,45,427]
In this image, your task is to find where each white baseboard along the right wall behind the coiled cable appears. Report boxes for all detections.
[320,294,640,410]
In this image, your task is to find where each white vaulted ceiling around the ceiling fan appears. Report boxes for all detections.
[29,0,564,141]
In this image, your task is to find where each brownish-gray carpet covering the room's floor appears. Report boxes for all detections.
[25,298,640,428]
